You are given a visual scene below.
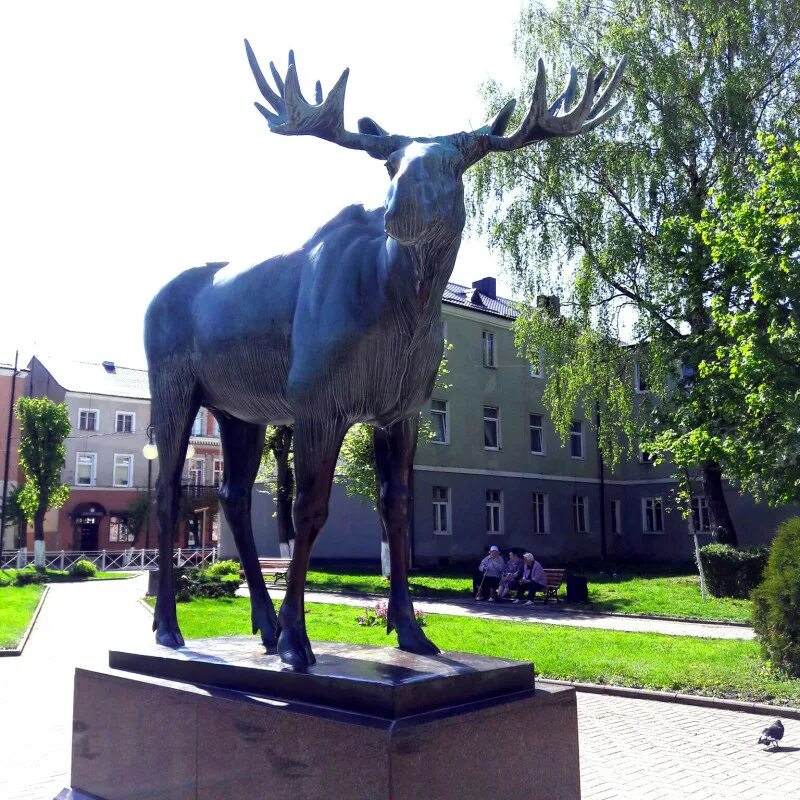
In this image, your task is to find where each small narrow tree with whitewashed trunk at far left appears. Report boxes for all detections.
[16,397,72,567]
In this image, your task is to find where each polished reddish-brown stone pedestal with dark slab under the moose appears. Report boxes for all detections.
[59,637,580,800]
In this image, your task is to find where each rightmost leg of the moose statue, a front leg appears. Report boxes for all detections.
[374,417,439,655]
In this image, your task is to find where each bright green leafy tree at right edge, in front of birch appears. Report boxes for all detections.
[660,131,800,503]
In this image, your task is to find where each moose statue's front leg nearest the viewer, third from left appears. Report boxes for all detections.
[278,418,346,667]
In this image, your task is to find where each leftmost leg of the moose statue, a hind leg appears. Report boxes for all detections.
[150,372,200,647]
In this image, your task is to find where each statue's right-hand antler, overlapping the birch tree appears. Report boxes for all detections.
[476,56,627,152]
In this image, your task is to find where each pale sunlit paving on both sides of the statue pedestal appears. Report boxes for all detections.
[0,578,800,800]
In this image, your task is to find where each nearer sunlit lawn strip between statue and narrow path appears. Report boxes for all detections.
[152,598,800,707]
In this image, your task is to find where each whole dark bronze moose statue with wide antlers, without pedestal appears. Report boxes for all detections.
[145,41,624,668]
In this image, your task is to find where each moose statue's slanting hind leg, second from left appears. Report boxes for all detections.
[219,414,278,653]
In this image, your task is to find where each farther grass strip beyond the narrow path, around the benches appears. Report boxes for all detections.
[306,566,750,622]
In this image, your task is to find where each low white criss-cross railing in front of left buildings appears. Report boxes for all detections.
[0,547,219,572]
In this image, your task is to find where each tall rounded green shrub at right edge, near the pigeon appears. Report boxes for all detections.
[753,517,800,678]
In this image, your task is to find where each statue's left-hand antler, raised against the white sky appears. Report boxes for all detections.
[244,39,411,158]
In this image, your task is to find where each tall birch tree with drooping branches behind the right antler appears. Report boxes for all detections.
[471,0,800,544]
